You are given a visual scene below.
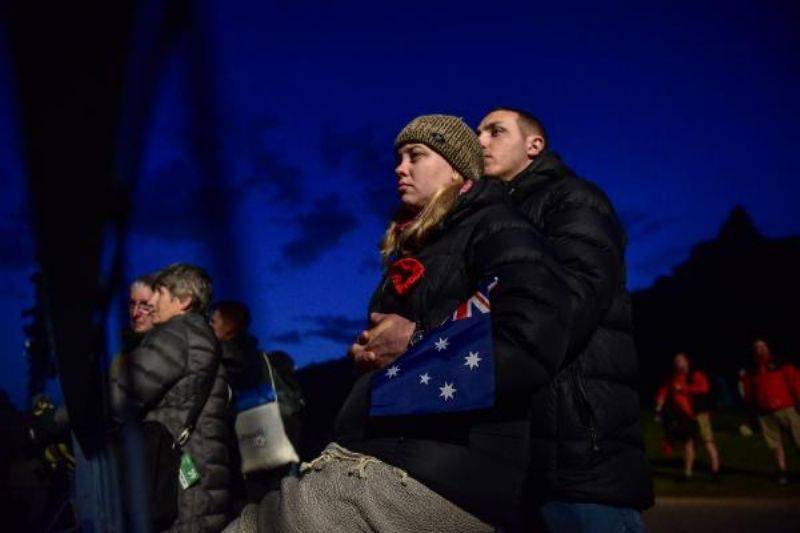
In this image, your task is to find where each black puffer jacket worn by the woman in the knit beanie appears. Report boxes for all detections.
[337,181,568,525]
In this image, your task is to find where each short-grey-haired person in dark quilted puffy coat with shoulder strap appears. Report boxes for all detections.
[111,263,232,532]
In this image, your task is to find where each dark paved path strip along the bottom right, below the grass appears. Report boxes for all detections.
[644,498,800,533]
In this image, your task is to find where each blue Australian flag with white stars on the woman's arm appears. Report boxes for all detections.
[369,278,497,416]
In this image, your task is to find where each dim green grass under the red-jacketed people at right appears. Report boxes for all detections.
[642,411,800,498]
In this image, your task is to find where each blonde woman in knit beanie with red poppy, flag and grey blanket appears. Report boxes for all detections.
[228,115,568,533]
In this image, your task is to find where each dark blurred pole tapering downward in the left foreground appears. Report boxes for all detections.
[5,0,134,452]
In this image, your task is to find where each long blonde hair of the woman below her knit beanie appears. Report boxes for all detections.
[380,172,464,265]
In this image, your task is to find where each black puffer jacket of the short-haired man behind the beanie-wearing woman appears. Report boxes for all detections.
[508,152,653,509]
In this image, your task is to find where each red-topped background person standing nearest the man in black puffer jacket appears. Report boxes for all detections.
[656,352,719,479]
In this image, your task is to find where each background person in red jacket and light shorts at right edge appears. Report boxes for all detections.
[740,339,800,485]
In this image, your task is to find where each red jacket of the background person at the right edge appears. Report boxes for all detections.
[740,363,800,413]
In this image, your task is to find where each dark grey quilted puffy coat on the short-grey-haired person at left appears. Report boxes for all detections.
[111,313,231,532]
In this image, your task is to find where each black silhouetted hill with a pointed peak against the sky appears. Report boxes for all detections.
[633,207,800,395]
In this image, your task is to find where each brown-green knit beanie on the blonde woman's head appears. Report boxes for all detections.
[394,115,483,180]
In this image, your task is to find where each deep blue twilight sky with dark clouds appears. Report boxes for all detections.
[0,1,800,408]
